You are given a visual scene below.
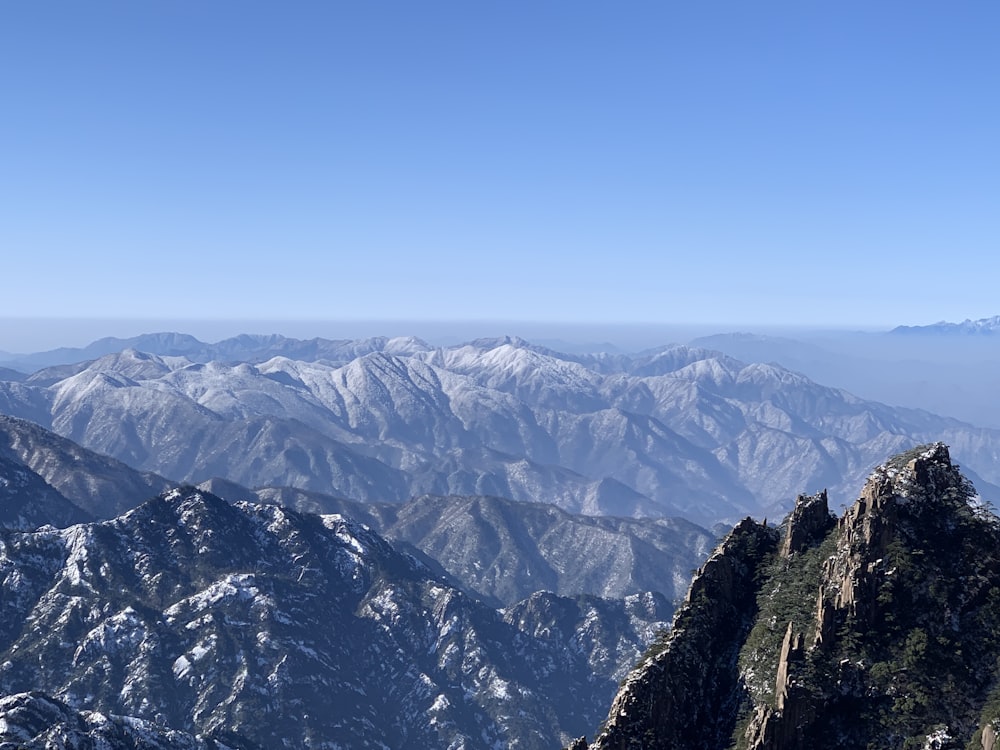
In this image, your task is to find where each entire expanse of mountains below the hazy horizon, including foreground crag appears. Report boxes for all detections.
[0,332,1000,750]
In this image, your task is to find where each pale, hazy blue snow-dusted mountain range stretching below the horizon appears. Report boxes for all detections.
[0,334,1000,525]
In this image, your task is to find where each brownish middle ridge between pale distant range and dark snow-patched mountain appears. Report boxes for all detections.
[373,495,714,605]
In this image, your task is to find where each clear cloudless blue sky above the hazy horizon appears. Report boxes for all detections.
[0,0,1000,328]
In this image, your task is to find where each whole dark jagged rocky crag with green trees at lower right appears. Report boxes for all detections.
[578,443,1000,750]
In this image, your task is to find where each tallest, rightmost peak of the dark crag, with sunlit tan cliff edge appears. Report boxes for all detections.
[744,443,1000,750]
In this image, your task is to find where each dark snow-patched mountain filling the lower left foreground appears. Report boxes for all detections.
[0,489,669,750]
